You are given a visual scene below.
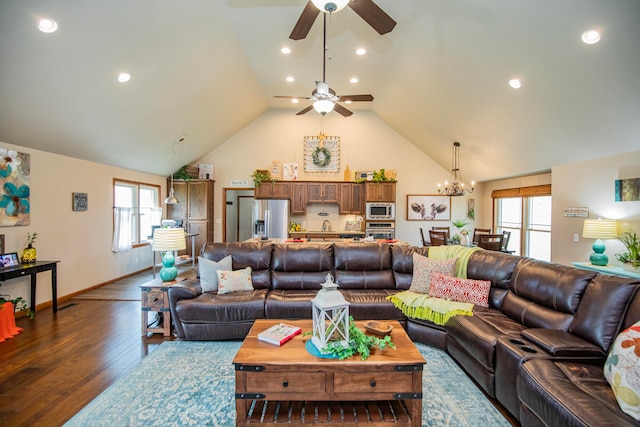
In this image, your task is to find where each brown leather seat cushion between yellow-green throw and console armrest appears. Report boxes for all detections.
[445,306,525,372]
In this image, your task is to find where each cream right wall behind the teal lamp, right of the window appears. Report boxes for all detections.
[551,151,640,265]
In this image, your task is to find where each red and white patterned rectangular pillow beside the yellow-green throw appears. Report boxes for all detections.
[429,273,491,307]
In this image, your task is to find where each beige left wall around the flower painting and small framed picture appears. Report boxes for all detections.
[0,143,166,304]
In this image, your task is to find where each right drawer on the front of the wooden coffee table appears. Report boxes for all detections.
[333,372,413,393]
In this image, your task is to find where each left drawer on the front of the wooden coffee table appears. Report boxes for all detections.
[246,372,325,393]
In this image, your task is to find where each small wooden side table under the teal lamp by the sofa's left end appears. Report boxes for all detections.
[140,277,185,337]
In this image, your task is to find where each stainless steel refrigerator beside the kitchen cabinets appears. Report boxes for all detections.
[252,199,289,239]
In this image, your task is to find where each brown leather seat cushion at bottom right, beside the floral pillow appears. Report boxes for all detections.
[516,359,638,427]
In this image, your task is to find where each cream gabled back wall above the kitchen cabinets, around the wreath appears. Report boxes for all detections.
[194,110,481,246]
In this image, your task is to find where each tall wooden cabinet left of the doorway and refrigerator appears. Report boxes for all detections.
[167,179,215,257]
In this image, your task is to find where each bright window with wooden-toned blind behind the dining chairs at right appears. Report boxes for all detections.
[491,185,551,261]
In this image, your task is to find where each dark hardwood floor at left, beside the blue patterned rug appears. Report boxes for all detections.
[0,275,173,427]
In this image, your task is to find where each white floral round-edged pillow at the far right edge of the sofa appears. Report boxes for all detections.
[604,322,640,421]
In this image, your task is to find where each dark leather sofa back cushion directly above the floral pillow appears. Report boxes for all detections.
[569,274,640,353]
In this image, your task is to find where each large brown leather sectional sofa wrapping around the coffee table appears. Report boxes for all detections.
[169,243,640,426]
